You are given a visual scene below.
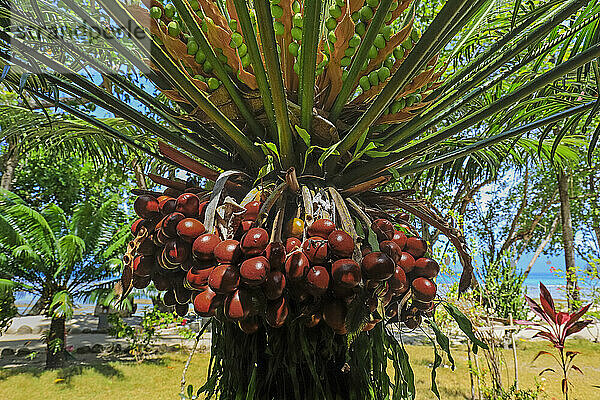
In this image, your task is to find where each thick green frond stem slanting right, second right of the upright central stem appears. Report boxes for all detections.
[338,0,472,159]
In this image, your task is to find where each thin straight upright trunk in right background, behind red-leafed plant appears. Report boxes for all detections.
[557,171,579,311]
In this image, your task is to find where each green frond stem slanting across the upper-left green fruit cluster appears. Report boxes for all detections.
[173,0,264,138]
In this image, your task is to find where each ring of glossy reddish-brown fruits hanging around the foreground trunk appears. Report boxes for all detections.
[131,193,439,334]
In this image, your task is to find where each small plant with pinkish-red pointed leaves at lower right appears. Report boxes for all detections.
[519,282,592,400]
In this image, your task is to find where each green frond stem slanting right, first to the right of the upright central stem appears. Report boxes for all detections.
[329,0,393,123]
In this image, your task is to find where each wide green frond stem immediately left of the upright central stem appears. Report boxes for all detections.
[254,0,295,168]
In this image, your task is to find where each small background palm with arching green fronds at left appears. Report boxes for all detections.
[0,191,130,368]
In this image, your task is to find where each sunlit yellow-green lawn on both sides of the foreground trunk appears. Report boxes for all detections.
[0,340,600,400]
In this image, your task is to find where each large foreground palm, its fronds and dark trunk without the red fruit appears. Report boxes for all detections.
[0,0,600,398]
